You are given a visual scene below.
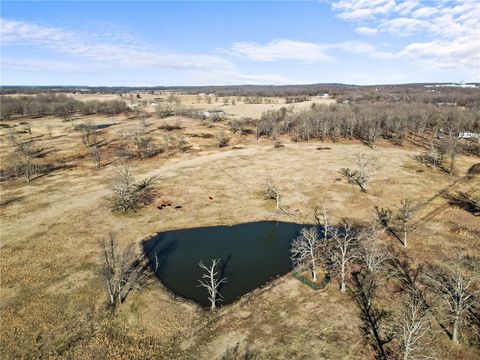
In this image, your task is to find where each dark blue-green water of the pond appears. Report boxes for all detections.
[144,221,305,306]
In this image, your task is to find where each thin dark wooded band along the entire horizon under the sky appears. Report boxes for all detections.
[0,84,480,106]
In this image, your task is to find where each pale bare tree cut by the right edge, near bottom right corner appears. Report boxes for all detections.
[426,258,480,344]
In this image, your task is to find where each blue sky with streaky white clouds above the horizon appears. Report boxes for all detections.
[0,0,480,86]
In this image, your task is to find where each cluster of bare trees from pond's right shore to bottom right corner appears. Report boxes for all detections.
[291,205,480,359]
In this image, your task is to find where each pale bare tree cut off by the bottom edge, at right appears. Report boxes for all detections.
[395,293,436,360]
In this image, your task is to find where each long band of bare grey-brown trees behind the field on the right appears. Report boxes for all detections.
[257,102,480,147]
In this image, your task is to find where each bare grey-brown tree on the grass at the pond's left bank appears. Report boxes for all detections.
[101,234,147,306]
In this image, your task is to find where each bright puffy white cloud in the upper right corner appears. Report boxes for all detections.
[332,0,480,73]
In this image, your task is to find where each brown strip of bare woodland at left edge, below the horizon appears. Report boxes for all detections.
[0,94,128,119]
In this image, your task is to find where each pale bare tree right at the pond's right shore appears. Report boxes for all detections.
[290,227,320,281]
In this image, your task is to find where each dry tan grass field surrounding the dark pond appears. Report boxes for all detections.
[0,95,480,359]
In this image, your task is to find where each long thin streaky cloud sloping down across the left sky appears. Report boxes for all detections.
[0,19,288,85]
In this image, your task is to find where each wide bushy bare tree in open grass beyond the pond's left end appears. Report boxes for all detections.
[109,166,158,213]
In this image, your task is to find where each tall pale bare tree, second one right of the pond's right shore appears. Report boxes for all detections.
[326,223,359,292]
